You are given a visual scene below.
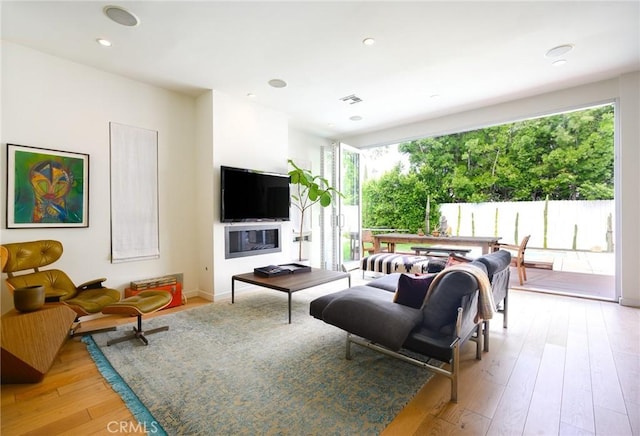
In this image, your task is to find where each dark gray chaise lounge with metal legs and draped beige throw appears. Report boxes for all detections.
[310,250,511,402]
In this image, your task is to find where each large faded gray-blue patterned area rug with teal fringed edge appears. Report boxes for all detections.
[86,290,431,435]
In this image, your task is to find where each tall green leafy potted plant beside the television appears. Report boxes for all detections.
[288,159,344,260]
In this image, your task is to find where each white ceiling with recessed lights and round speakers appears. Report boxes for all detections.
[1,0,640,138]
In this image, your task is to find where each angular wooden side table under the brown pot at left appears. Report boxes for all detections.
[0,303,76,384]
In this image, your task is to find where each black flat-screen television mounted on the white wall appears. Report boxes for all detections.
[220,166,290,223]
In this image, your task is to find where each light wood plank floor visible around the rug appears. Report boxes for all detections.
[1,291,640,436]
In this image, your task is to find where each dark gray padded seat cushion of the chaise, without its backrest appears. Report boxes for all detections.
[312,286,422,351]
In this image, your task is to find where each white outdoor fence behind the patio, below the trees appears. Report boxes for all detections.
[440,200,615,251]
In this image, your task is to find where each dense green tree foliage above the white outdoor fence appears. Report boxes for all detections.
[363,105,614,229]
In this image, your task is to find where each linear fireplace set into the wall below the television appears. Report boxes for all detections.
[224,225,282,259]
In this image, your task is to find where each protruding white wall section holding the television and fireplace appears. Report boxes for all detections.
[191,95,329,299]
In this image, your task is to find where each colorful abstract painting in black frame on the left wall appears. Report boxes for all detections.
[7,144,89,228]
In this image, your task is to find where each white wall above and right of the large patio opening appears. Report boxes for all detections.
[343,72,640,306]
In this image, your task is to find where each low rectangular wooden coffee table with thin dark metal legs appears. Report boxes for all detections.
[231,268,351,324]
